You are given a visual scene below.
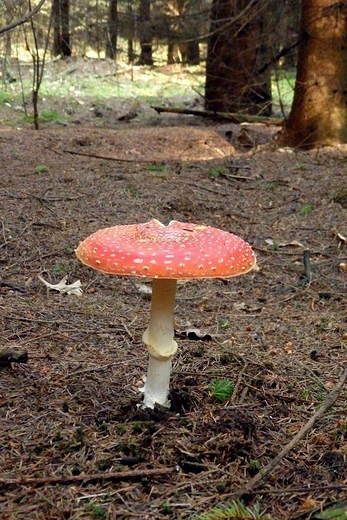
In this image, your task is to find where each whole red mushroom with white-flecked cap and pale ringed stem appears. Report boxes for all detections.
[76,220,256,408]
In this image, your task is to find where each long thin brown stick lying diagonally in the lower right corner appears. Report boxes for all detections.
[232,365,347,498]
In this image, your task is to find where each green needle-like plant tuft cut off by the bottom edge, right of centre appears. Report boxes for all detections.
[193,500,270,520]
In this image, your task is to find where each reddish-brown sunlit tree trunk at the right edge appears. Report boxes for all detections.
[279,0,347,148]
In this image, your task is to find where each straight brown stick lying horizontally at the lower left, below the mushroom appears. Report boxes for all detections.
[0,466,177,486]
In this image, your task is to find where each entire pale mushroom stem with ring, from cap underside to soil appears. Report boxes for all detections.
[143,278,177,408]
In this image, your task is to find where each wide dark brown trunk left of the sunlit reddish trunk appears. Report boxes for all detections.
[205,0,271,115]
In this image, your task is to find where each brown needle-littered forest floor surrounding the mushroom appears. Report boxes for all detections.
[0,59,347,520]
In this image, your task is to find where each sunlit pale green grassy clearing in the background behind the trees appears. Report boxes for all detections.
[0,58,295,118]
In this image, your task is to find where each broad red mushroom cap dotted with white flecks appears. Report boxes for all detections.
[76,219,256,279]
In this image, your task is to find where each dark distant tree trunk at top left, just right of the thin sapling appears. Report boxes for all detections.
[52,0,71,57]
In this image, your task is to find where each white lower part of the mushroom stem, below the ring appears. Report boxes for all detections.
[141,355,171,408]
